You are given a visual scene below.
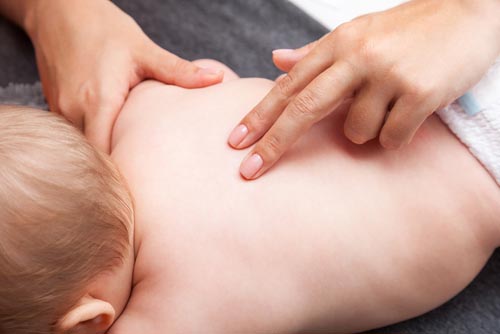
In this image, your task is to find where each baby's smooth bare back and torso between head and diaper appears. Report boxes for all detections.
[110,75,500,334]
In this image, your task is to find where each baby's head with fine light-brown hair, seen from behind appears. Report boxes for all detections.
[0,107,133,334]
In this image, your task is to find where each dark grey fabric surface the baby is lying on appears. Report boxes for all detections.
[0,0,500,334]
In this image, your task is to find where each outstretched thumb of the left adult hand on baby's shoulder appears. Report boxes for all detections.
[139,43,224,88]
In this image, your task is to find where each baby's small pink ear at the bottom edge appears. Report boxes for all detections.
[57,295,115,334]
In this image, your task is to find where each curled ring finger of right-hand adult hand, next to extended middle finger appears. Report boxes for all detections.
[344,84,392,144]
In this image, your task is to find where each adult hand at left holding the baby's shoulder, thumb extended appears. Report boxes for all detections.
[26,0,223,152]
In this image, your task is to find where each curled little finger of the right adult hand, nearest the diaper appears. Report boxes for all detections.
[379,95,437,149]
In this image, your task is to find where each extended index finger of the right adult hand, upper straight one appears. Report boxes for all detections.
[228,38,333,149]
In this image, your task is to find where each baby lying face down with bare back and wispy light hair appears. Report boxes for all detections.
[0,63,500,334]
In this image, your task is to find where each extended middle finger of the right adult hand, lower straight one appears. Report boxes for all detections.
[240,62,360,180]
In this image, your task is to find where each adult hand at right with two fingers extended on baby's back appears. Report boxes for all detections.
[229,0,500,179]
